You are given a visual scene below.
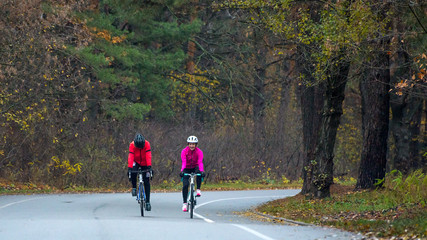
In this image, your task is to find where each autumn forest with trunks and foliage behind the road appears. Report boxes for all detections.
[0,0,427,198]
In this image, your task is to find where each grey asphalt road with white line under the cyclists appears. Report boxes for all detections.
[0,190,363,240]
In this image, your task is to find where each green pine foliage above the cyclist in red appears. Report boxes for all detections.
[73,0,201,120]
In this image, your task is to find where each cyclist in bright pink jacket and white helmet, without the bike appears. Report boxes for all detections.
[179,136,205,212]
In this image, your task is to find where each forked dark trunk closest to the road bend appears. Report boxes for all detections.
[301,0,350,198]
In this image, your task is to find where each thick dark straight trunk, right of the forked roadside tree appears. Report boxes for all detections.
[356,42,390,189]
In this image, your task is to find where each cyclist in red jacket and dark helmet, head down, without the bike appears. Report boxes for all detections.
[128,133,153,211]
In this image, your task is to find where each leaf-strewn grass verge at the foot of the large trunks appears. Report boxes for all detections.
[256,172,427,239]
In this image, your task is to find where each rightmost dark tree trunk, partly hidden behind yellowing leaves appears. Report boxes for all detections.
[390,13,423,174]
